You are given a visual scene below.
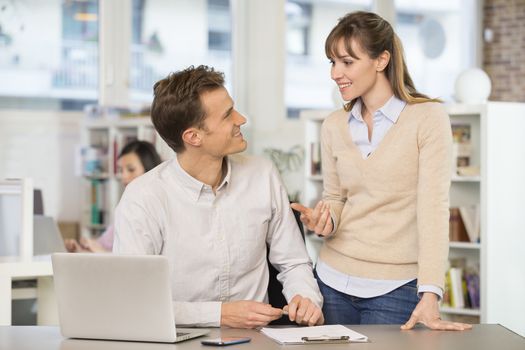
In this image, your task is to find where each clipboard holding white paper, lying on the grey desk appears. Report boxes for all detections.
[261,325,368,345]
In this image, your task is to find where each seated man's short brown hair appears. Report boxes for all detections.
[151,65,224,152]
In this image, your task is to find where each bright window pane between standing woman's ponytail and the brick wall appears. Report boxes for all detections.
[395,0,476,101]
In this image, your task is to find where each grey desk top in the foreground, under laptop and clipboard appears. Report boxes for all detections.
[0,324,525,350]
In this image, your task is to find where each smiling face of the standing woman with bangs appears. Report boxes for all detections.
[331,39,379,101]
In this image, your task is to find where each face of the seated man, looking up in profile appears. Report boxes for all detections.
[200,88,247,157]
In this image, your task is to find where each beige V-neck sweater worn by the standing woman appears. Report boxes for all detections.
[320,102,452,289]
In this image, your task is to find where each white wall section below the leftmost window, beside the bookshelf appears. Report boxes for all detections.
[0,110,83,221]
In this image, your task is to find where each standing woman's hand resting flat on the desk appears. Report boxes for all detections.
[401,293,472,331]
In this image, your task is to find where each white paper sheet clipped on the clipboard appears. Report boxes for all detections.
[261,325,368,344]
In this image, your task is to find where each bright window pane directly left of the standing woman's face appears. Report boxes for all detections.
[285,0,372,118]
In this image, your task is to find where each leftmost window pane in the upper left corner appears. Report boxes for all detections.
[0,0,98,109]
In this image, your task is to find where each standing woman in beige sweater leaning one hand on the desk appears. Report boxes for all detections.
[292,12,471,330]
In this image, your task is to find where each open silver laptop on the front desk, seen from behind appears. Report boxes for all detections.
[51,253,209,343]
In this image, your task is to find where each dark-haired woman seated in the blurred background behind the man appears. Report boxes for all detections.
[65,141,161,253]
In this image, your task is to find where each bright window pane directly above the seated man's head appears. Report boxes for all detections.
[130,0,232,104]
